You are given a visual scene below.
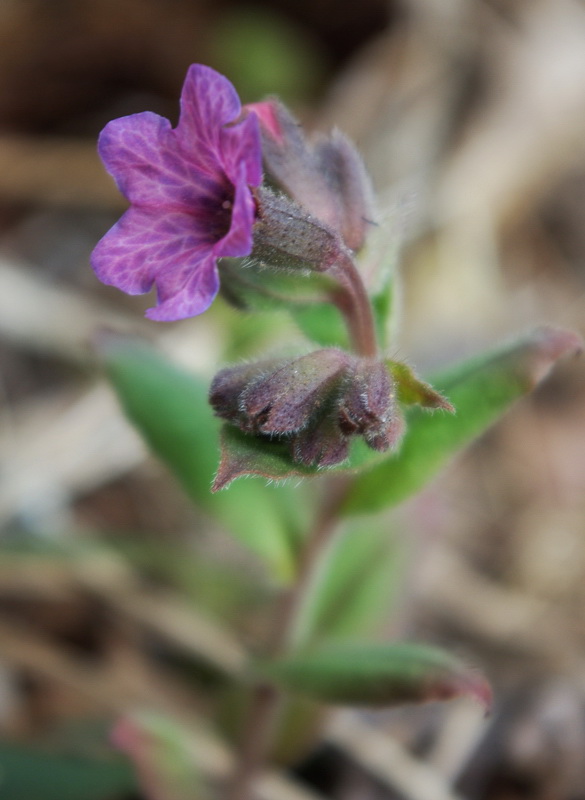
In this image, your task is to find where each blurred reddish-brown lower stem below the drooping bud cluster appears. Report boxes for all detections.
[226,477,350,800]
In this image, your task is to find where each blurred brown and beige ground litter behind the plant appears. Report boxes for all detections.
[0,0,585,800]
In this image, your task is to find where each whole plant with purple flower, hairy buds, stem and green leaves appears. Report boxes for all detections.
[92,65,580,800]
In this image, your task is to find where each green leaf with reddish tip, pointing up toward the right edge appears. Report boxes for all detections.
[344,327,581,514]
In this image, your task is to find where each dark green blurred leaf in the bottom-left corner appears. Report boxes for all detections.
[0,743,137,800]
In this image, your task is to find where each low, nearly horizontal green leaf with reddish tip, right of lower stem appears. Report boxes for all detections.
[261,642,491,708]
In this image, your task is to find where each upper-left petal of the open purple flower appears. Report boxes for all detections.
[98,111,225,212]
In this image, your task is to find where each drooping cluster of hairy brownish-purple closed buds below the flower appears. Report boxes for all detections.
[209,348,402,467]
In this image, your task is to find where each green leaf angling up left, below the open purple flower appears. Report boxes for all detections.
[100,336,306,580]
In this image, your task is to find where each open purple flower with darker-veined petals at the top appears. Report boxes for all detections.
[91,64,262,321]
